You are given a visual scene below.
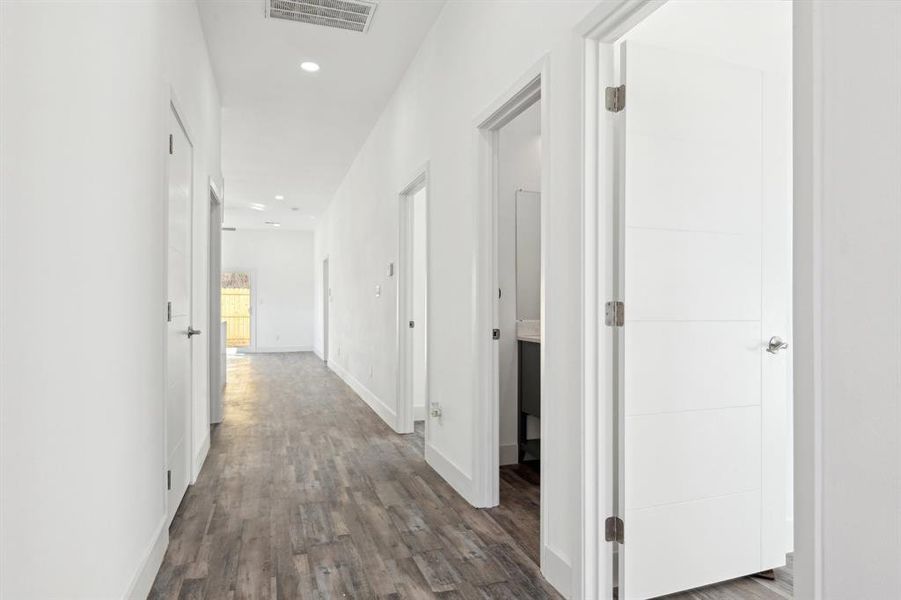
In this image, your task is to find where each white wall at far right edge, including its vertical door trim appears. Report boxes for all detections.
[794,1,901,600]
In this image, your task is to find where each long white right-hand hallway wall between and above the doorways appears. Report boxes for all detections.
[317,1,596,591]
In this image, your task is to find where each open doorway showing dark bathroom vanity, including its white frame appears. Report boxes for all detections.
[474,61,557,572]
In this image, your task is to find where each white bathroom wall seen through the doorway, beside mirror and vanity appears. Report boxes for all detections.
[497,103,541,464]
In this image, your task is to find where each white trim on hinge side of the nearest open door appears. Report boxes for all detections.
[576,0,664,599]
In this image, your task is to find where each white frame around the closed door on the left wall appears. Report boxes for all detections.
[161,96,197,523]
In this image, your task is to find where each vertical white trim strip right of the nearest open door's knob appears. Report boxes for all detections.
[792,2,824,600]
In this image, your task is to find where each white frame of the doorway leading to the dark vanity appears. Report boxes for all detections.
[470,55,554,548]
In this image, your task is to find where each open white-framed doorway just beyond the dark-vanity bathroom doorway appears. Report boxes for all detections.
[400,167,429,455]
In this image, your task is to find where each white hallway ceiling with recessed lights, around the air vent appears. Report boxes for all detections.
[199,0,444,229]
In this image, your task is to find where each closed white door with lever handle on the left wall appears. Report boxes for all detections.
[166,111,192,520]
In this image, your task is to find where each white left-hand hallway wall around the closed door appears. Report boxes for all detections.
[0,1,219,599]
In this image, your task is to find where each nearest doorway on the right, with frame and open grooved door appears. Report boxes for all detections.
[582,0,793,598]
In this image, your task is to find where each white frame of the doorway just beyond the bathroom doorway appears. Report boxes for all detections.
[394,162,431,436]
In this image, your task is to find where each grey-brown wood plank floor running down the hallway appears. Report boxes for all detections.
[150,353,559,599]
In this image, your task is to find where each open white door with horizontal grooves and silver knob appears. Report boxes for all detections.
[613,43,790,599]
